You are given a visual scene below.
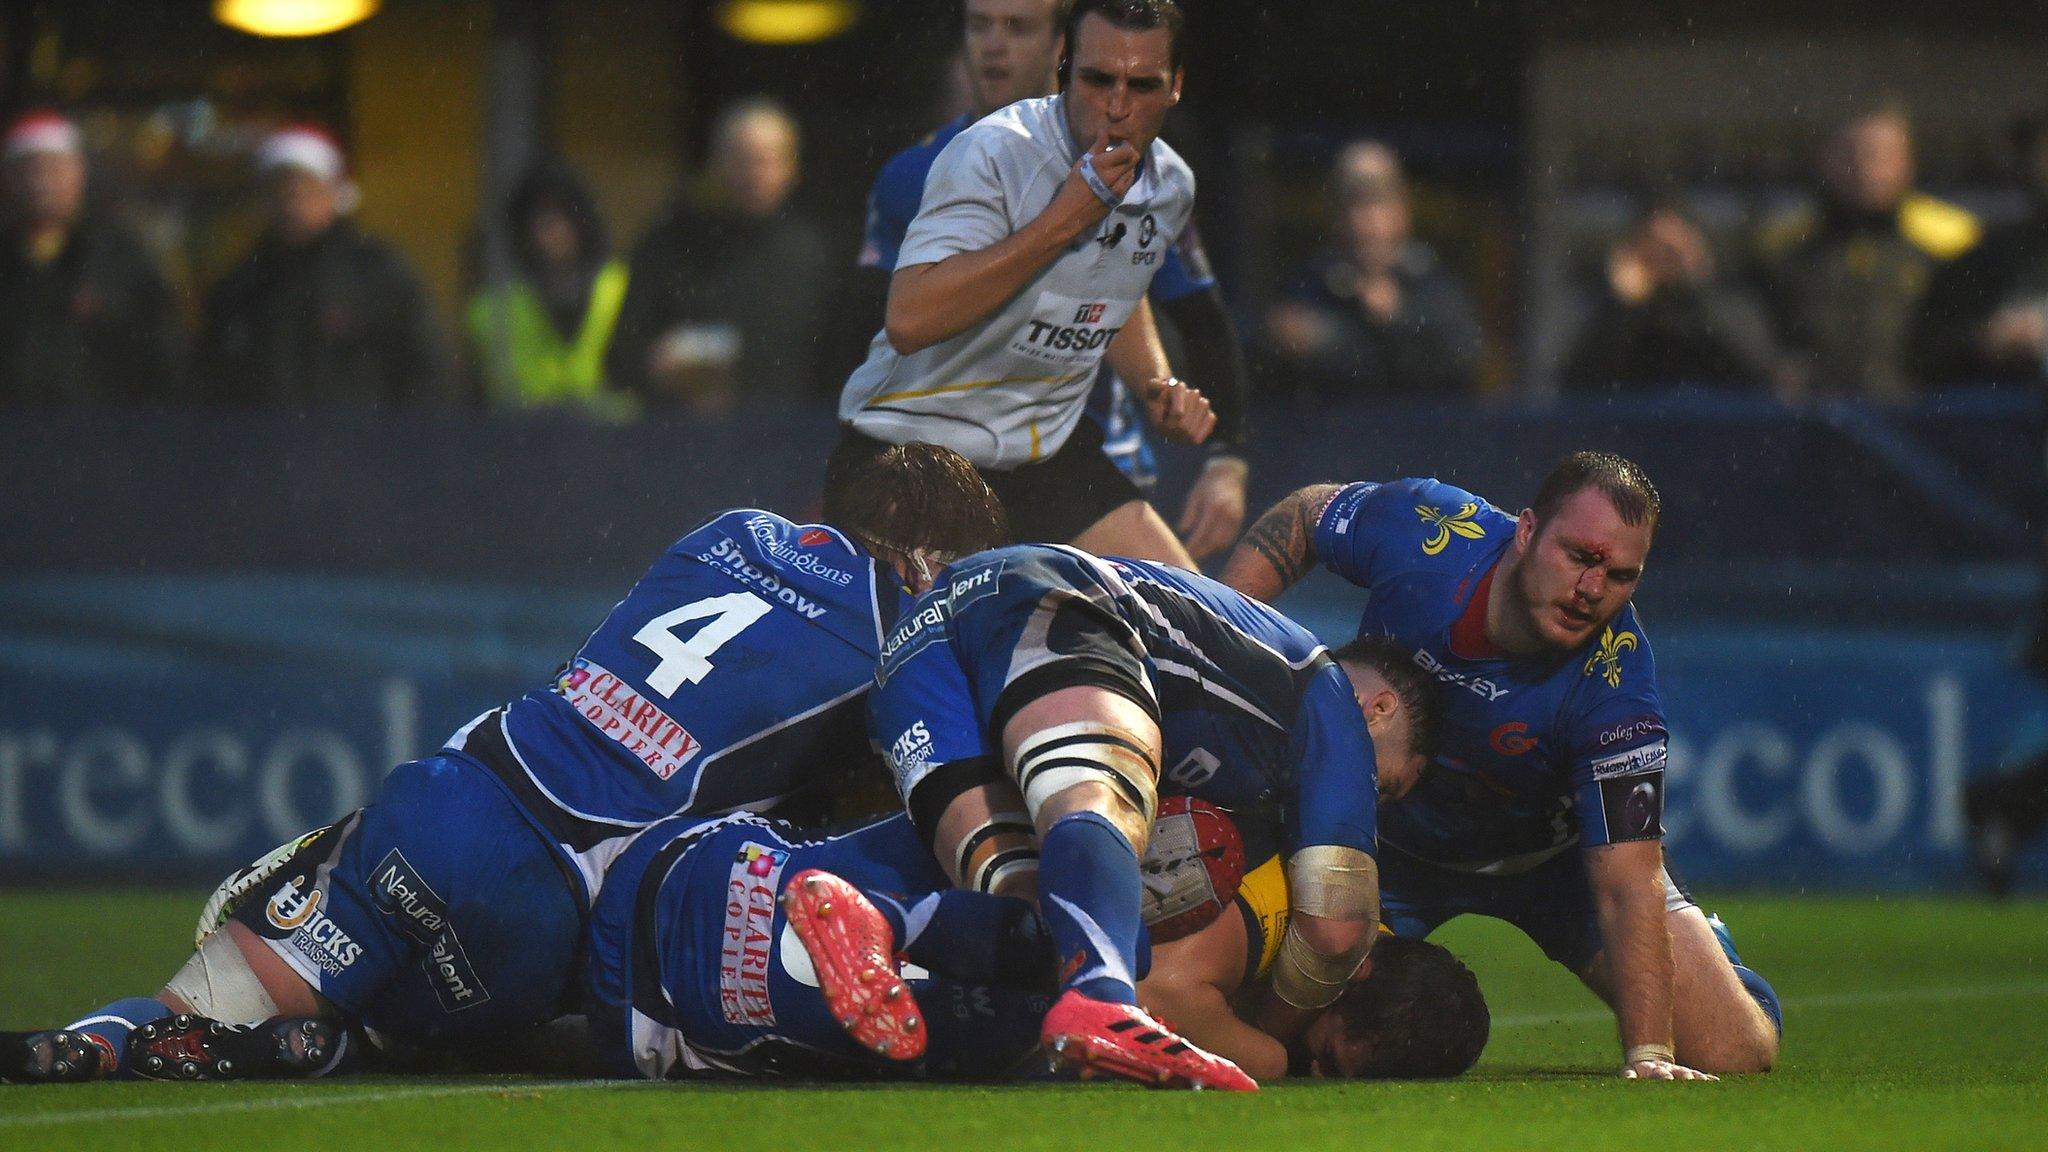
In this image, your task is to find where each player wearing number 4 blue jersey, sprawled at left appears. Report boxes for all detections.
[0,445,1004,1080]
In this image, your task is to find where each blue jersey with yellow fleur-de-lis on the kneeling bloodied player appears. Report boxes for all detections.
[1315,480,1667,873]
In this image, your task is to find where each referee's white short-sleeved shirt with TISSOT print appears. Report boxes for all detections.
[840,96,1194,469]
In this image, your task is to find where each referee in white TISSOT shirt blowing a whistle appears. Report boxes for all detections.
[834,0,1217,566]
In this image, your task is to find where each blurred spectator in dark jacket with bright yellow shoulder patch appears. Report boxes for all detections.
[1763,105,1978,402]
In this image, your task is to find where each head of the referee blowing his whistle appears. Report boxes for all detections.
[1067,14,1180,148]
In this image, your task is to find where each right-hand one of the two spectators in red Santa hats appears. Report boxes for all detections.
[197,127,451,410]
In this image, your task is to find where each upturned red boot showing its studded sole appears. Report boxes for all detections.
[776,867,926,1060]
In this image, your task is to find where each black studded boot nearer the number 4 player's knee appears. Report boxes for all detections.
[127,1013,346,1080]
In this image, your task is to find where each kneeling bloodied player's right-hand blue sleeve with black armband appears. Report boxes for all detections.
[1563,611,1669,847]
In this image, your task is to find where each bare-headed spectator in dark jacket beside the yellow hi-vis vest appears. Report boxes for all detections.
[610,100,836,412]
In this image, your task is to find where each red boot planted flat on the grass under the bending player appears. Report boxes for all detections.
[1038,988,1260,1093]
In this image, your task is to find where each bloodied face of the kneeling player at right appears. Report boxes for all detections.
[1511,488,1651,648]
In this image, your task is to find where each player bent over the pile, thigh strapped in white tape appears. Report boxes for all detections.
[868,545,1432,1086]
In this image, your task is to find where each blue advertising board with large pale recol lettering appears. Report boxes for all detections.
[0,629,2048,888]
